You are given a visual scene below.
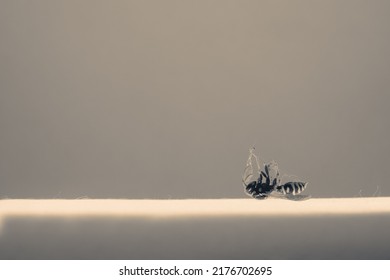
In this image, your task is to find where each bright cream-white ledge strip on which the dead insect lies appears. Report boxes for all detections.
[0,197,390,219]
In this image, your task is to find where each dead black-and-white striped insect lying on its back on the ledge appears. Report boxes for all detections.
[242,148,310,201]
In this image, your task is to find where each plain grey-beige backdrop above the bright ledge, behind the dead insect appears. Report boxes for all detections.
[0,0,390,199]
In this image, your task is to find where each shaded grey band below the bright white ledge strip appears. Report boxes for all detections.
[0,215,390,260]
